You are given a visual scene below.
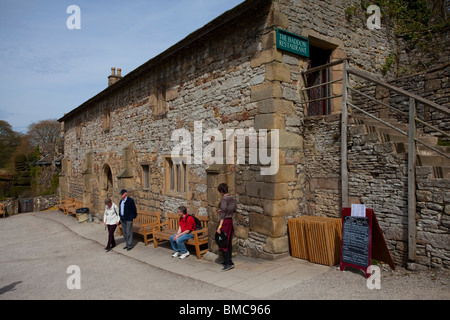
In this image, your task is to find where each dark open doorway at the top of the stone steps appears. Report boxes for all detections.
[307,46,331,116]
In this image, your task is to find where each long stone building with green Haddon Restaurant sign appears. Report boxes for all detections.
[59,0,450,267]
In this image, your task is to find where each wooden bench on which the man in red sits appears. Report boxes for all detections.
[153,212,208,259]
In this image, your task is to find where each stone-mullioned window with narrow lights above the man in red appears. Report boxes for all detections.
[165,157,188,198]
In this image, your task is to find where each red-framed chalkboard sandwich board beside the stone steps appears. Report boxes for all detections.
[340,208,395,277]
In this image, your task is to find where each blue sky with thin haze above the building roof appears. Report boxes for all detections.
[0,0,244,133]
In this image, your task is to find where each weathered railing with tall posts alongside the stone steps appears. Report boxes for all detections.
[302,59,450,261]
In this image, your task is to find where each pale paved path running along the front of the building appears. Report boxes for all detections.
[0,211,330,299]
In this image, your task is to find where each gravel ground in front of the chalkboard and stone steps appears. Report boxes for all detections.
[271,265,450,300]
